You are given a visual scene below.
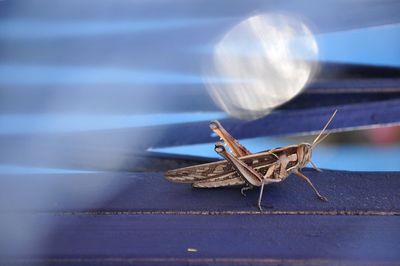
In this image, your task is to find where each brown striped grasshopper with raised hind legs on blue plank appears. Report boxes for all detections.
[165,110,337,211]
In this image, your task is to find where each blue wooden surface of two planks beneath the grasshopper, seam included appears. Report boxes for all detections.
[0,169,400,265]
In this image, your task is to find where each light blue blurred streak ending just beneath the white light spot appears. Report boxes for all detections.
[0,112,227,134]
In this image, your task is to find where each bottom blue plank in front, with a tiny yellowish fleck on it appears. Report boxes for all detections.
[0,215,400,265]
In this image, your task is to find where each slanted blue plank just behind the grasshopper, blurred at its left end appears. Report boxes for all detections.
[0,99,400,170]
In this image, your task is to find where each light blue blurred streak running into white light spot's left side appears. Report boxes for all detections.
[0,64,247,86]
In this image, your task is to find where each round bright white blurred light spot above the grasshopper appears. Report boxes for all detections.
[204,14,318,119]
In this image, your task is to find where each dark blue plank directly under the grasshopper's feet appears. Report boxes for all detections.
[0,169,400,212]
